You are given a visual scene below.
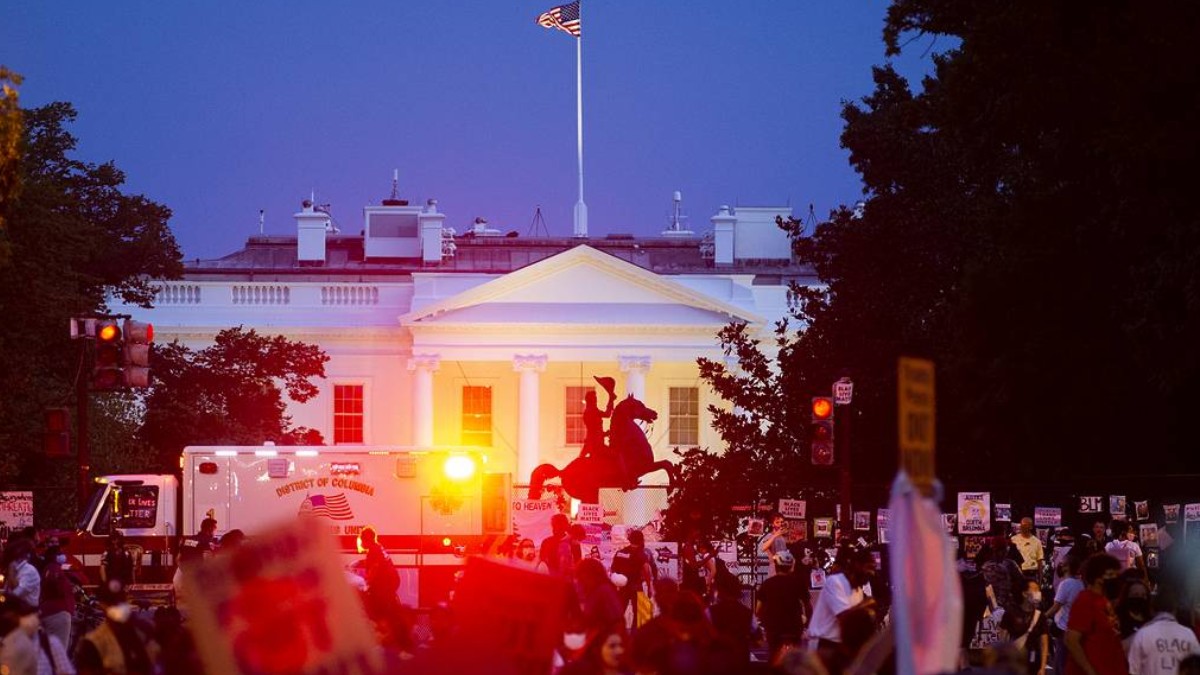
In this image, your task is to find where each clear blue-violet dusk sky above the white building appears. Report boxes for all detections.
[0,0,946,258]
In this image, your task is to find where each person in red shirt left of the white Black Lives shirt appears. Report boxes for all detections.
[1066,554,1129,675]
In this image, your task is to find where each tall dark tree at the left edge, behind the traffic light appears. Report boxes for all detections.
[0,103,182,497]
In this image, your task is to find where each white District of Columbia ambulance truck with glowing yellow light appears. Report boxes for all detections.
[68,446,512,607]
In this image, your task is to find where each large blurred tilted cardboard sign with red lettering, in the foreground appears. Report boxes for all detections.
[184,518,384,674]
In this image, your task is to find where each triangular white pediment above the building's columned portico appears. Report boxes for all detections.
[400,245,763,329]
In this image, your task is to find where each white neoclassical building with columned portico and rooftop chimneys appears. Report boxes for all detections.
[119,198,816,483]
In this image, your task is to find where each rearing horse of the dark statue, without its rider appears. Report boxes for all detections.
[529,394,674,504]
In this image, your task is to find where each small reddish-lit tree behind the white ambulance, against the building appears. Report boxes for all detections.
[140,327,329,471]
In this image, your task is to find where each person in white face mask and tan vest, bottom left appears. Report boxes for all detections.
[76,580,158,675]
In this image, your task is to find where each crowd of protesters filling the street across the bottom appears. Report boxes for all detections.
[0,506,1200,675]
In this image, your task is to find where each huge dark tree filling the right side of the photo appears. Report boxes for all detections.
[667,0,1200,535]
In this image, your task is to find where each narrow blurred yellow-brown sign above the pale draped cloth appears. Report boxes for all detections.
[896,357,936,494]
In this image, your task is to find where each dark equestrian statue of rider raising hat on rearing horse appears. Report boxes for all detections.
[529,377,674,504]
